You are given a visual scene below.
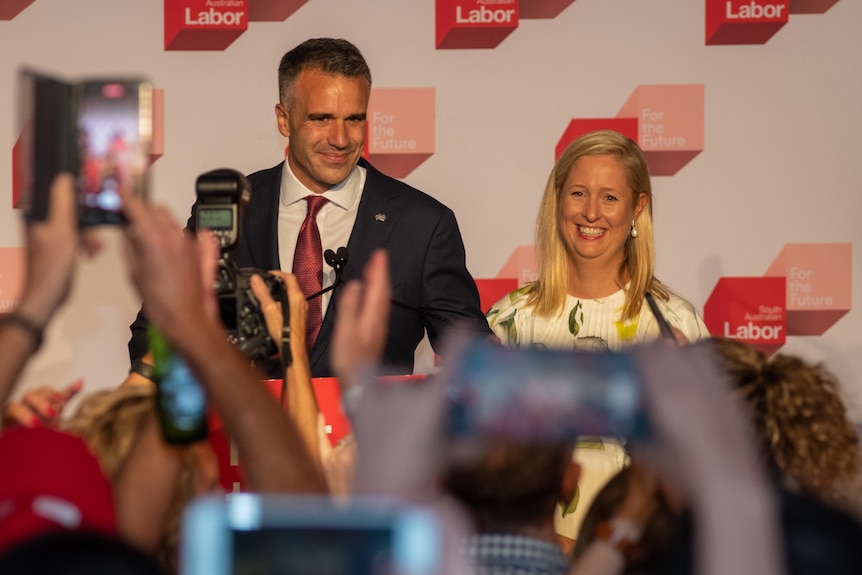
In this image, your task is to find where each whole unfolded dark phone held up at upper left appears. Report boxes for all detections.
[16,69,153,227]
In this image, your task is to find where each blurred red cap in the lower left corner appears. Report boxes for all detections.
[0,428,117,552]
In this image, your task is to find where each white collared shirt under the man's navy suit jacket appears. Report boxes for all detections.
[278,160,365,315]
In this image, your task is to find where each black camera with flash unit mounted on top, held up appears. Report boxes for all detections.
[194,168,289,360]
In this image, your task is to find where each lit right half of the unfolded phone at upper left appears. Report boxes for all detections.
[76,80,152,226]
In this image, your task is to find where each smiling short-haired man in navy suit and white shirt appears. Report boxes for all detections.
[129,38,491,377]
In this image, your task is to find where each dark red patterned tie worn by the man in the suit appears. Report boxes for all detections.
[293,195,329,353]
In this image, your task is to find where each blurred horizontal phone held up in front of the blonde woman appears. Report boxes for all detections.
[447,339,649,442]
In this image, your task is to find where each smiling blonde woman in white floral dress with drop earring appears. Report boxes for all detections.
[486,130,709,350]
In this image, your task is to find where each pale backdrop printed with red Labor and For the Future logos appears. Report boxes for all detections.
[0,0,862,428]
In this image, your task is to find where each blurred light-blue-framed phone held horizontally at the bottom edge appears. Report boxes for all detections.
[180,493,443,575]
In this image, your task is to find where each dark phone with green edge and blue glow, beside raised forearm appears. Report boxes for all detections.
[148,325,209,445]
